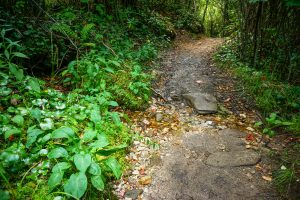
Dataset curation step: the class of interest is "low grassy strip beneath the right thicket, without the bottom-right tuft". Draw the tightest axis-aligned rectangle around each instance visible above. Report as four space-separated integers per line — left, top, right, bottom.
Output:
215 45 300 136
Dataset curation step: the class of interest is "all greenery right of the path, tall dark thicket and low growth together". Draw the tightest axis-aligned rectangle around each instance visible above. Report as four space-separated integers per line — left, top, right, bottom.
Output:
215 0 300 199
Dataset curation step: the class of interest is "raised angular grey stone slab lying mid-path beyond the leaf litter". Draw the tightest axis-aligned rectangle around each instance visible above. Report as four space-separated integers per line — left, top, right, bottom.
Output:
182 93 218 114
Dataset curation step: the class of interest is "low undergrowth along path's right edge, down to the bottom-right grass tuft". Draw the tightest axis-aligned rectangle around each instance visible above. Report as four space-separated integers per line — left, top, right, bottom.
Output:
214 44 300 198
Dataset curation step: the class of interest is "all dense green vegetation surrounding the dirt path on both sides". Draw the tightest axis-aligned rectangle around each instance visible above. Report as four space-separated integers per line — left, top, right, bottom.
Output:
0 0 300 199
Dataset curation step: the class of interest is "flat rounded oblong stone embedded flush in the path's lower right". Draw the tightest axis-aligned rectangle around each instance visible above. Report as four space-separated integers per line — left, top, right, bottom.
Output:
205 150 261 167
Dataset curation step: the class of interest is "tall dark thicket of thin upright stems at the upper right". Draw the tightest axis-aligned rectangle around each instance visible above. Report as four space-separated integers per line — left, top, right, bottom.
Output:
225 0 300 85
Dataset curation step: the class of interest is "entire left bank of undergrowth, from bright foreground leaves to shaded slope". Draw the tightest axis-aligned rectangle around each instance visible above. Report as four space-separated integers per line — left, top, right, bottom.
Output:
0 1 174 199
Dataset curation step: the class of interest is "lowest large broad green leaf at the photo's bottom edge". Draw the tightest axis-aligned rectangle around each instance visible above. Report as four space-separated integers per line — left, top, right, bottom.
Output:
64 172 87 199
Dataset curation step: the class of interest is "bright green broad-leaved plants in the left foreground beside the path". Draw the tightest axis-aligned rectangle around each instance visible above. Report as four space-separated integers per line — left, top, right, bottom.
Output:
0 31 130 198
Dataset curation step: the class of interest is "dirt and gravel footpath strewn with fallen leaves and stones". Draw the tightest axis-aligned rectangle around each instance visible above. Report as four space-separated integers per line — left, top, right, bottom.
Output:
115 35 278 200
